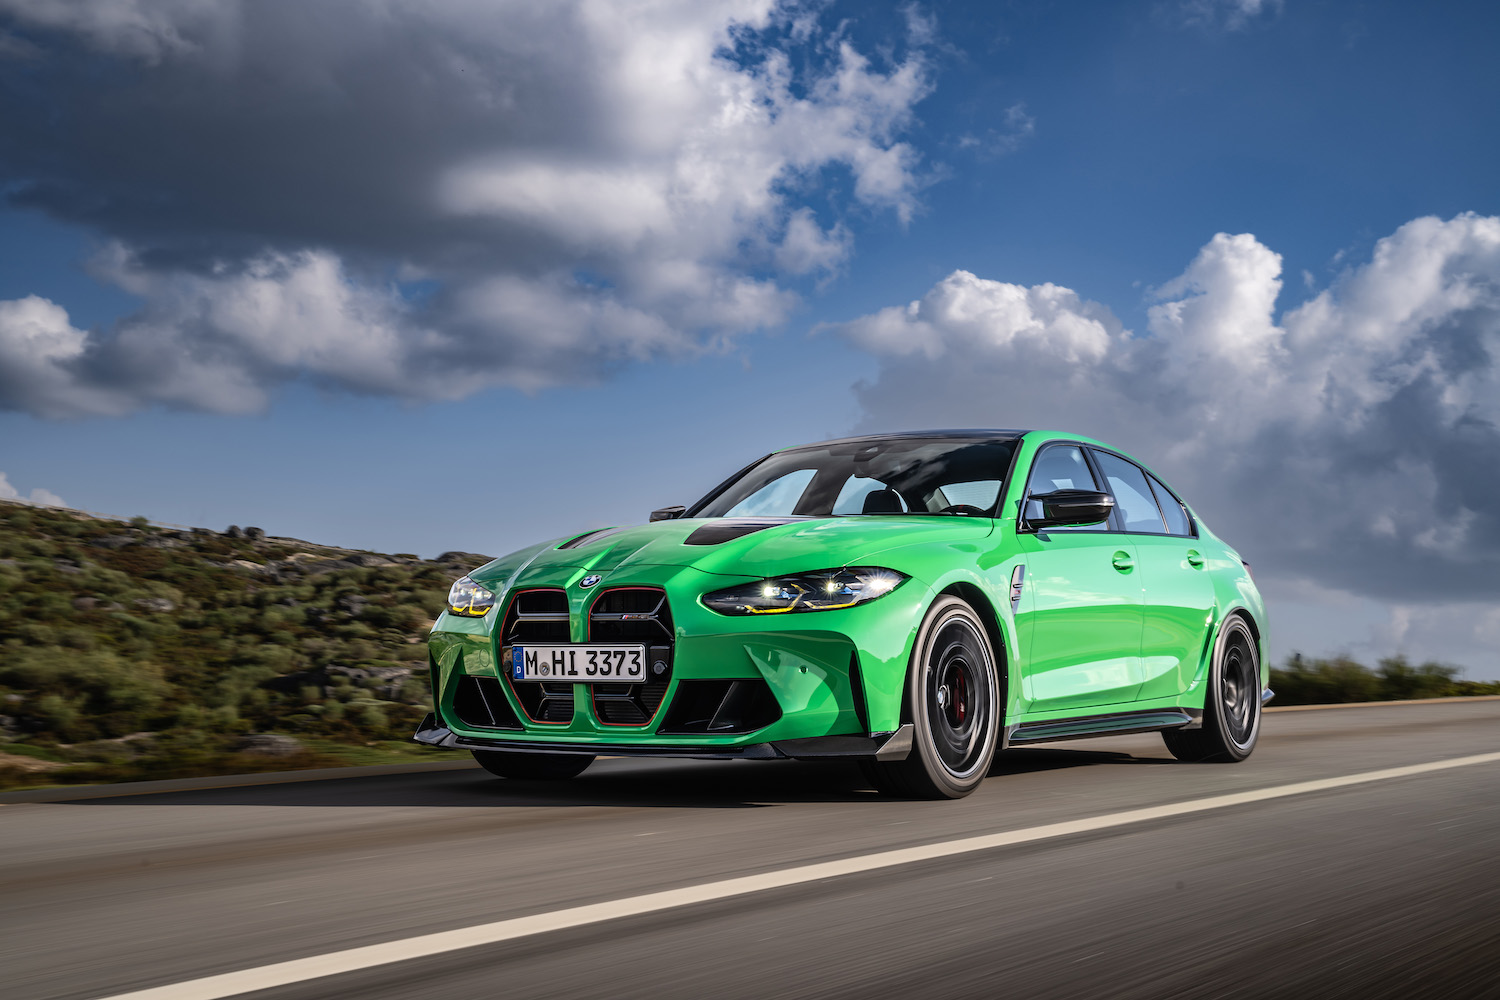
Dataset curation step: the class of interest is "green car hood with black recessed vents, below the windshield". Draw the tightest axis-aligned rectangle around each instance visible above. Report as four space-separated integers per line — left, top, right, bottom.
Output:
471 514 995 589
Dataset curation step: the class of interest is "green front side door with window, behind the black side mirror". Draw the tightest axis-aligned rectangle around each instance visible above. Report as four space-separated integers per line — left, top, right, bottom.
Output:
1016 444 1143 712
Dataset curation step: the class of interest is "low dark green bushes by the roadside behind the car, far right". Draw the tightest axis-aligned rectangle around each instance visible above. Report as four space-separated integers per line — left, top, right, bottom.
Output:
1271 654 1500 705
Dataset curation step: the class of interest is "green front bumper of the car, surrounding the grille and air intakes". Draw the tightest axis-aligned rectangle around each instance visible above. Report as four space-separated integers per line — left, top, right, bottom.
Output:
419 567 927 749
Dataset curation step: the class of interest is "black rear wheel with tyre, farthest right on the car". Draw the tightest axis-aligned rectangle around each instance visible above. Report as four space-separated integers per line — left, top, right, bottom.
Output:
1161 615 1260 763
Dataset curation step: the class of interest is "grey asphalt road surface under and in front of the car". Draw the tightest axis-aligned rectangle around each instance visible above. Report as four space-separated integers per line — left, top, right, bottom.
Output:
0 702 1500 1000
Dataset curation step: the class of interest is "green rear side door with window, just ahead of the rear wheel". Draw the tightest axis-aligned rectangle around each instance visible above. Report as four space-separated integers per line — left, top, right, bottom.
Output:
1094 448 1214 700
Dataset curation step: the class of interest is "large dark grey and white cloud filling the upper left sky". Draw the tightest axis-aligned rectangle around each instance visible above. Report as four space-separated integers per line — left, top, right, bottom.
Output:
0 0 932 417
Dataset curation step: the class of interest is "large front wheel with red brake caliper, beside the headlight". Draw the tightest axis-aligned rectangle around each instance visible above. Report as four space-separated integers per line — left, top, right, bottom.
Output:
863 597 1004 799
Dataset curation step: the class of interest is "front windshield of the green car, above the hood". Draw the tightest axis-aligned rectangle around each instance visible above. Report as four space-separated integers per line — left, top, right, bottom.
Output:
690 438 1016 517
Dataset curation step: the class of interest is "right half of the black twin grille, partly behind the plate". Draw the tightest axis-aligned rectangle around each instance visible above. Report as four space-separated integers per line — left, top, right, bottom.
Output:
588 586 677 727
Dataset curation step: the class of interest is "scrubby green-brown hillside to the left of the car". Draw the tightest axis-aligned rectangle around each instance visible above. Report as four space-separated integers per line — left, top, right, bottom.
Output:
0 504 488 786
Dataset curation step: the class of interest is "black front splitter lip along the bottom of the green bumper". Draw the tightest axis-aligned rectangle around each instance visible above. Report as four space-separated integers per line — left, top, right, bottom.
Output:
413 712 912 760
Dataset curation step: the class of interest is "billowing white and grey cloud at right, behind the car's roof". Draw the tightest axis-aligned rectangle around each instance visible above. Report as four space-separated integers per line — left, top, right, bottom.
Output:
839 214 1500 617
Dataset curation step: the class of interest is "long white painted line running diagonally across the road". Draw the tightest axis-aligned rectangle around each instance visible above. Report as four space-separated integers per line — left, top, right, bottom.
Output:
90 753 1500 1000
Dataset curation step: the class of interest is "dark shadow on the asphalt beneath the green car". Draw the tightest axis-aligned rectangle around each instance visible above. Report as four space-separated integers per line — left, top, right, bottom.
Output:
59 747 1166 810
